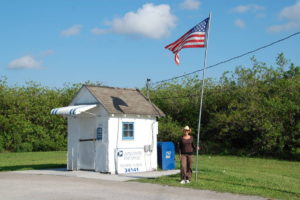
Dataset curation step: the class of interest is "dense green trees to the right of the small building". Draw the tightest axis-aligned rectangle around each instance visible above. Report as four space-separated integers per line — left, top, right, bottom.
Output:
150 53 300 157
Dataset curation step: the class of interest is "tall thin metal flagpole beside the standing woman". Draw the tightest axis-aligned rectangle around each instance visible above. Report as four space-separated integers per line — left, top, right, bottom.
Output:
195 12 211 182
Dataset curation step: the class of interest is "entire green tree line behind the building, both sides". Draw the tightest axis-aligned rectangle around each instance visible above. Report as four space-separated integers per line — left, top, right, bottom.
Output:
0 53 300 157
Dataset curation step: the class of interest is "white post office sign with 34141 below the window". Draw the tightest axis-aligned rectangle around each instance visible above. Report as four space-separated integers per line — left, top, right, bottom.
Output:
116 149 146 174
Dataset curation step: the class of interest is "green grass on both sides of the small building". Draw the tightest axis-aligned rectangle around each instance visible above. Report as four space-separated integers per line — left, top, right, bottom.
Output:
0 151 300 199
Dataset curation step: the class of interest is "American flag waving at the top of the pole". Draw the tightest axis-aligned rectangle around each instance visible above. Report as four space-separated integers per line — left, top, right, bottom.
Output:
165 18 209 65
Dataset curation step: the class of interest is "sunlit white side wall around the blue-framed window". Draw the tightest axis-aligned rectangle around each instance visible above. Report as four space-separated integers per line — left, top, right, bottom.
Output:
108 115 158 173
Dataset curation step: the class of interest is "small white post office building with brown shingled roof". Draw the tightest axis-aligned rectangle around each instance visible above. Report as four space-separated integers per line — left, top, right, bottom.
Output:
51 85 164 174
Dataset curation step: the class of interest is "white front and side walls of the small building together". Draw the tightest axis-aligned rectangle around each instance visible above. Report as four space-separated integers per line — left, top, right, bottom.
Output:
67 87 158 174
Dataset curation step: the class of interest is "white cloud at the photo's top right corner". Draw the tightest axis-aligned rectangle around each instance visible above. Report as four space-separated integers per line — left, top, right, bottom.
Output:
267 0 300 32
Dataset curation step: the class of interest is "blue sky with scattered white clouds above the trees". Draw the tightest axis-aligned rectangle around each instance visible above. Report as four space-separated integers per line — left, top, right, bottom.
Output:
0 0 300 88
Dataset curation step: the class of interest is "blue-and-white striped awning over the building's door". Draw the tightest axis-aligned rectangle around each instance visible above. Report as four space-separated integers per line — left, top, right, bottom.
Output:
50 104 97 115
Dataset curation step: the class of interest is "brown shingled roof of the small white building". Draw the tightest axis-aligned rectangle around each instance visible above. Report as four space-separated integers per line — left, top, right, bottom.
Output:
83 85 165 117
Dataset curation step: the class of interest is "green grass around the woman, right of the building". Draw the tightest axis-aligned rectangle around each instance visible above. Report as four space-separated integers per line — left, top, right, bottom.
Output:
139 155 300 199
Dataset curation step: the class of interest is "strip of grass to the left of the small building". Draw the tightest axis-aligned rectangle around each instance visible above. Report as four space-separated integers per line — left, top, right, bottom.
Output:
0 151 67 171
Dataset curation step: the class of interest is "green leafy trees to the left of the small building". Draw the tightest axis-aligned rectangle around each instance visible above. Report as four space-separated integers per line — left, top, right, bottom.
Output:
0 78 78 152
